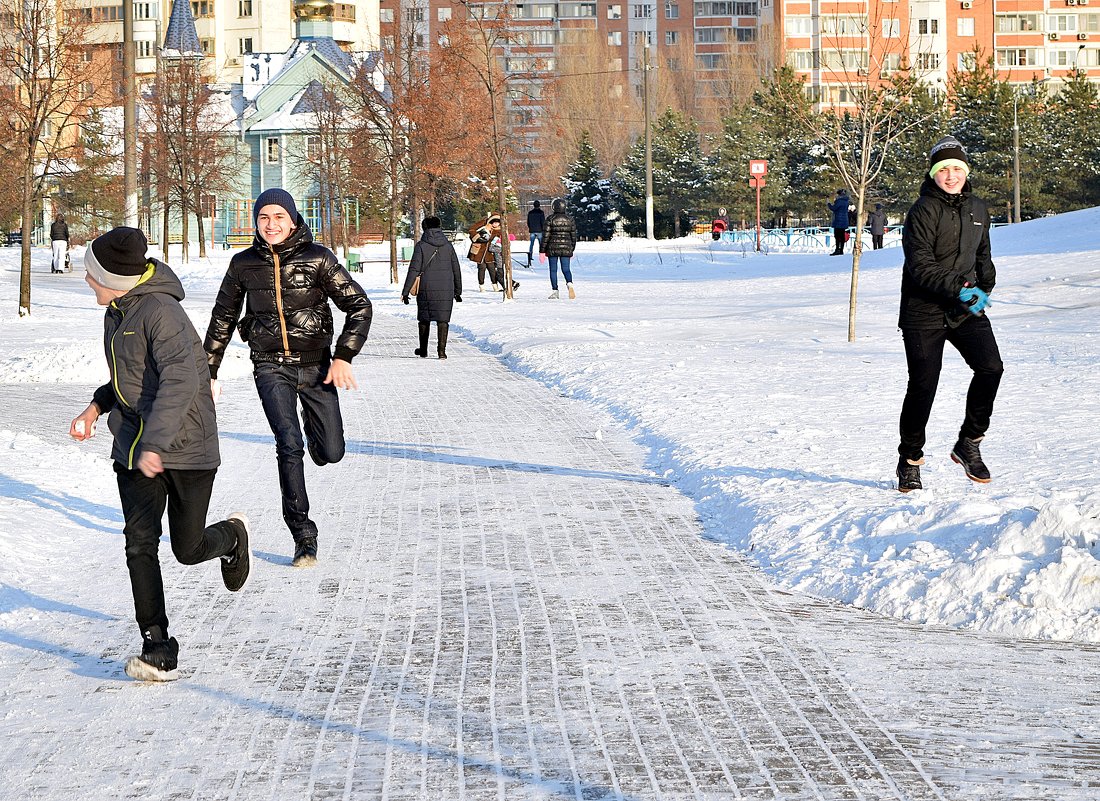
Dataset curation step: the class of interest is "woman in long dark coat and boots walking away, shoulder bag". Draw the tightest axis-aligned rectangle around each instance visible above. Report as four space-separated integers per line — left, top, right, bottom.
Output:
402 217 462 359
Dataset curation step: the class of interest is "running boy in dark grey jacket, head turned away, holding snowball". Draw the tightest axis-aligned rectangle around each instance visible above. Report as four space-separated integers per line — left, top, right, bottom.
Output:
69 228 251 681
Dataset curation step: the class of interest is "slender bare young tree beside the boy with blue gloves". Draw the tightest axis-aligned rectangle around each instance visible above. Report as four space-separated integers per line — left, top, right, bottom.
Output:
770 9 933 342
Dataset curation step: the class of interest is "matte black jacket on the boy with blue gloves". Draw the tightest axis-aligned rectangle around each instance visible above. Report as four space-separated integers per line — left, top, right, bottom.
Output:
898 178 997 329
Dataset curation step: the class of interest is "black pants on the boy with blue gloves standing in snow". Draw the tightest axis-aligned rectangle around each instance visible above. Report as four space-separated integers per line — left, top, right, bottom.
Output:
898 315 1004 461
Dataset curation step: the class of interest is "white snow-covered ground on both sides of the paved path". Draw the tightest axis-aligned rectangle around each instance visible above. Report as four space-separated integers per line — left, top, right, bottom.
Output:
0 209 1100 643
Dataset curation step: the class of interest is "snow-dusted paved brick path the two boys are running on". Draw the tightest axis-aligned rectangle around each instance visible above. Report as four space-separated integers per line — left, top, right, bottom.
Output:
0 317 1100 801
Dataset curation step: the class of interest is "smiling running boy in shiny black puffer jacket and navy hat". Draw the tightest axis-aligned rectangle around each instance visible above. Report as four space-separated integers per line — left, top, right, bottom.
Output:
205 189 371 568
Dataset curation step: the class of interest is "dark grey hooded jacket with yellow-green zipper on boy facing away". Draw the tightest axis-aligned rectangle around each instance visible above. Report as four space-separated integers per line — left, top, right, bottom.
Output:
92 260 221 470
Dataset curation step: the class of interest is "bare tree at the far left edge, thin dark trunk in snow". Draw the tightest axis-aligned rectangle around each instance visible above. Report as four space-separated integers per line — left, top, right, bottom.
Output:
0 0 90 317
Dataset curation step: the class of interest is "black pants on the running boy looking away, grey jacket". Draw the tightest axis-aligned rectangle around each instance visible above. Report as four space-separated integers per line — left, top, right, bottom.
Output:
114 462 237 634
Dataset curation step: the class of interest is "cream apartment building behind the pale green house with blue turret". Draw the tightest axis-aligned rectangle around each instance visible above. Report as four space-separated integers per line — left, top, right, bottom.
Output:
80 0 378 87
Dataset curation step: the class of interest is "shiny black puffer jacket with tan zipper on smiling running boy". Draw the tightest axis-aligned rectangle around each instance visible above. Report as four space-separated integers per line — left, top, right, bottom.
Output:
205 215 372 377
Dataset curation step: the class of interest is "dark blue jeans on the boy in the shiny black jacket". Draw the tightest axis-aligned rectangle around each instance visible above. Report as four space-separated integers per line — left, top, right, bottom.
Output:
253 359 344 541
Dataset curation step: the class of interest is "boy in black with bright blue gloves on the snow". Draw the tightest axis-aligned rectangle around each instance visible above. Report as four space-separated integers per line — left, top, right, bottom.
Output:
898 136 1004 492
